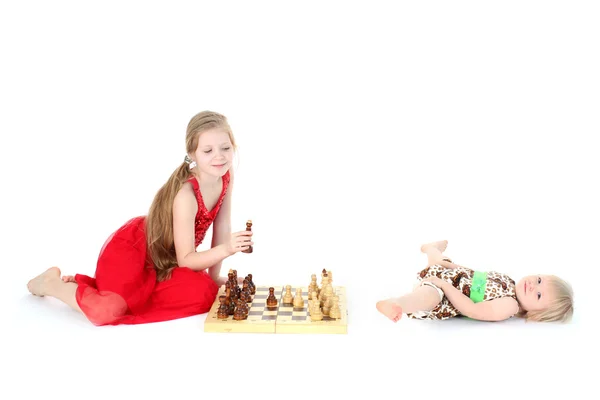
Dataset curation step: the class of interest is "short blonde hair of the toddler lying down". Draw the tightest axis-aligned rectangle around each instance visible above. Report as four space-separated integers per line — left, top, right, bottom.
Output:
519 275 573 322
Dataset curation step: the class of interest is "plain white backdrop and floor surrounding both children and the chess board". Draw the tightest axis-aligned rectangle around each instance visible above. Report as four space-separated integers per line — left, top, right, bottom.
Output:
0 1 600 399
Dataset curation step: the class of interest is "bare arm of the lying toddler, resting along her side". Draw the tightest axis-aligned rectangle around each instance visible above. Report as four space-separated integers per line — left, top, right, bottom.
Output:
433 279 519 321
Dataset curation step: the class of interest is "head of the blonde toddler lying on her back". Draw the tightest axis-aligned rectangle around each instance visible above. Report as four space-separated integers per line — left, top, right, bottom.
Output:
515 275 573 322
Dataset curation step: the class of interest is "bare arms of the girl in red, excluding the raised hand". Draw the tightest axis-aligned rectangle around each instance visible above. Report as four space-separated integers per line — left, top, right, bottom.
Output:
173 183 233 279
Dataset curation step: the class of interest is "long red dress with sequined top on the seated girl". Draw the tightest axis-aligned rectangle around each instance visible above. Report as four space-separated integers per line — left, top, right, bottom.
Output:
75 172 229 325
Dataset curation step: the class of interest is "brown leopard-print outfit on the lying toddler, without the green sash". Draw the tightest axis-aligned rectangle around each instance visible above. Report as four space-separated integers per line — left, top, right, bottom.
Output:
407 265 517 320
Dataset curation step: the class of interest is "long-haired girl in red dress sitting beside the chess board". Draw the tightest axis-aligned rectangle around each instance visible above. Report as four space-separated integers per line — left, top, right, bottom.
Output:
27 111 254 325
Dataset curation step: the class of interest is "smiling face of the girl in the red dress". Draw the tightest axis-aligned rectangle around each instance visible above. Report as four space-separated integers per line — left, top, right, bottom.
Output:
192 128 233 178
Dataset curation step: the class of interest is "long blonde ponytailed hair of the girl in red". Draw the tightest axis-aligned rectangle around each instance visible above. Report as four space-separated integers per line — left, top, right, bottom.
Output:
146 111 236 281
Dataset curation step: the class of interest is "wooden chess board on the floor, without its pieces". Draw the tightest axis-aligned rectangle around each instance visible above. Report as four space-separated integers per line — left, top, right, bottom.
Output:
204 286 348 334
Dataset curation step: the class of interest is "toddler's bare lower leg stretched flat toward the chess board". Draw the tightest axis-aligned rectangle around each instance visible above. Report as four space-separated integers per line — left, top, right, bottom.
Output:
377 285 440 322
